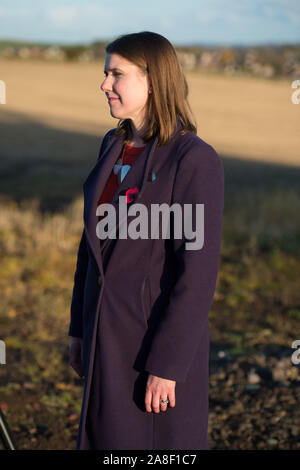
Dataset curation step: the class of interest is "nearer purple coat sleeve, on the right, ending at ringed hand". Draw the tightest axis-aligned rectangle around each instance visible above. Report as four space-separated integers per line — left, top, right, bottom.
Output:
145 143 224 382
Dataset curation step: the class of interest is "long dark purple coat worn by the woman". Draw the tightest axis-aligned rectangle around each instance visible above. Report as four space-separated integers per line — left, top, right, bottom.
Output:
68 115 224 450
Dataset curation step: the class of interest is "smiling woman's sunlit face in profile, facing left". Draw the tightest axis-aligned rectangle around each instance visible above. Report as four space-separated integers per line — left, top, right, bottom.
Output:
100 53 150 128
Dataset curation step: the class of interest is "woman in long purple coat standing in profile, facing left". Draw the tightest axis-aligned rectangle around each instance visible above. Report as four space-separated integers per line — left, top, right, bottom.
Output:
69 32 224 450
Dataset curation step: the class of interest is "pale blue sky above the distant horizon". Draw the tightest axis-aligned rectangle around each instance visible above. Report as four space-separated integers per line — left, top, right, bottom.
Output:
0 0 300 45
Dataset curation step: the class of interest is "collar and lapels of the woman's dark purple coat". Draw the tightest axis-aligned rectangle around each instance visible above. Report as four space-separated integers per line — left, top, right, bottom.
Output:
83 116 183 277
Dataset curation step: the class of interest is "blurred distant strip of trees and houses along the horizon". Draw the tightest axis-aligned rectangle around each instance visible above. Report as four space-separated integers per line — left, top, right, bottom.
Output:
0 41 300 79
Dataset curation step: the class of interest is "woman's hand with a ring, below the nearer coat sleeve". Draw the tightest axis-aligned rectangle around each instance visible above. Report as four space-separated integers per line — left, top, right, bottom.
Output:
145 374 176 413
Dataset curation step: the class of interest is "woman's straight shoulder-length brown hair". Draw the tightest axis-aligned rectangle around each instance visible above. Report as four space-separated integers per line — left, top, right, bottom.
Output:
105 31 197 146
